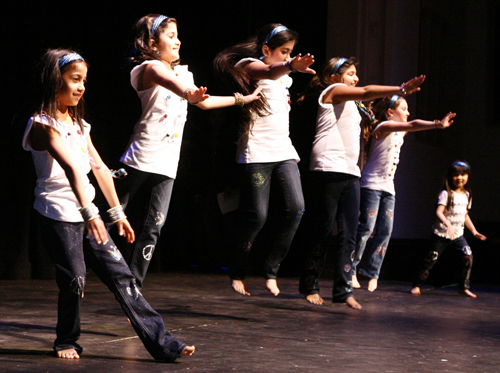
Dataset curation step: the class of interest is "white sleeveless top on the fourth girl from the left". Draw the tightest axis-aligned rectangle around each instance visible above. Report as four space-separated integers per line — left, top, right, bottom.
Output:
309 83 361 177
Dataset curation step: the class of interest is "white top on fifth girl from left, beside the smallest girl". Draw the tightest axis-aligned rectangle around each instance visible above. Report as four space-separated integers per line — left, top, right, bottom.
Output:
360 122 405 195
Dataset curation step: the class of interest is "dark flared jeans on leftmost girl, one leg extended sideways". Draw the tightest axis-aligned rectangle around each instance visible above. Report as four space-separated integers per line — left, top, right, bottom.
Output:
39 215 186 361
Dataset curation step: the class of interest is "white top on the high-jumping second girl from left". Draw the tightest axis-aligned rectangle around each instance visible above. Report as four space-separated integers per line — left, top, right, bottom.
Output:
120 60 194 178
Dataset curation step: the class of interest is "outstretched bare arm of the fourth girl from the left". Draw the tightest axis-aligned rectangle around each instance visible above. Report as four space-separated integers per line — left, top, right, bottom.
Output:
325 75 425 103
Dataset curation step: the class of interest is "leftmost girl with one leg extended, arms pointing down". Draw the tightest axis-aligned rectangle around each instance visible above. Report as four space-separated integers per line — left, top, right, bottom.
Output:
23 49 195 362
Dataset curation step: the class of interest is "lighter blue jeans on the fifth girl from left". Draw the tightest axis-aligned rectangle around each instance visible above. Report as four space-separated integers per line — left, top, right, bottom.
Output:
352 188 396 279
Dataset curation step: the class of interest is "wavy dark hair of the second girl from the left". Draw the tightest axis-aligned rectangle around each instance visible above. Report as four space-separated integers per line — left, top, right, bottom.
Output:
129 14 180 68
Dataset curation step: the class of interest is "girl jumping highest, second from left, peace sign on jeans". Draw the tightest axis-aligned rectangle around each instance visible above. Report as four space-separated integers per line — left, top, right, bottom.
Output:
117 14 260 288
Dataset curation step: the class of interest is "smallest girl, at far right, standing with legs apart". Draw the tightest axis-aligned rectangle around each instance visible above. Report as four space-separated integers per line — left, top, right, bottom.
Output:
411 161 486 298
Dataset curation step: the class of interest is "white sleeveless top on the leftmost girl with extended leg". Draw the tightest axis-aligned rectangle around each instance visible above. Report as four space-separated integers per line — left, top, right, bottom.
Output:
23 115 95 222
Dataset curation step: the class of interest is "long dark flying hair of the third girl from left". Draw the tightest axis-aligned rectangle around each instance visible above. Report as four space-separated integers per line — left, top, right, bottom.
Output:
214 23 299 142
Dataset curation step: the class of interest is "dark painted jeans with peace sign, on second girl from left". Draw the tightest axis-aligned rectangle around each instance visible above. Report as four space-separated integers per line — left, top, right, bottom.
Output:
116 166 175 289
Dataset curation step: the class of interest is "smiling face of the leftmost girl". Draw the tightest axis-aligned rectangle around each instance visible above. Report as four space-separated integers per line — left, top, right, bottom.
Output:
57 62 88 112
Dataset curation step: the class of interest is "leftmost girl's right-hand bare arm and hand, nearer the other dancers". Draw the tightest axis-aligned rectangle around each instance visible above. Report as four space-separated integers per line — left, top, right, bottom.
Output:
87 136 135 243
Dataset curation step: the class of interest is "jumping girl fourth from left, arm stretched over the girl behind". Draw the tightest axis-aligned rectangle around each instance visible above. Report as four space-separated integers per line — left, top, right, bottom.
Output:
299 57 425 309
